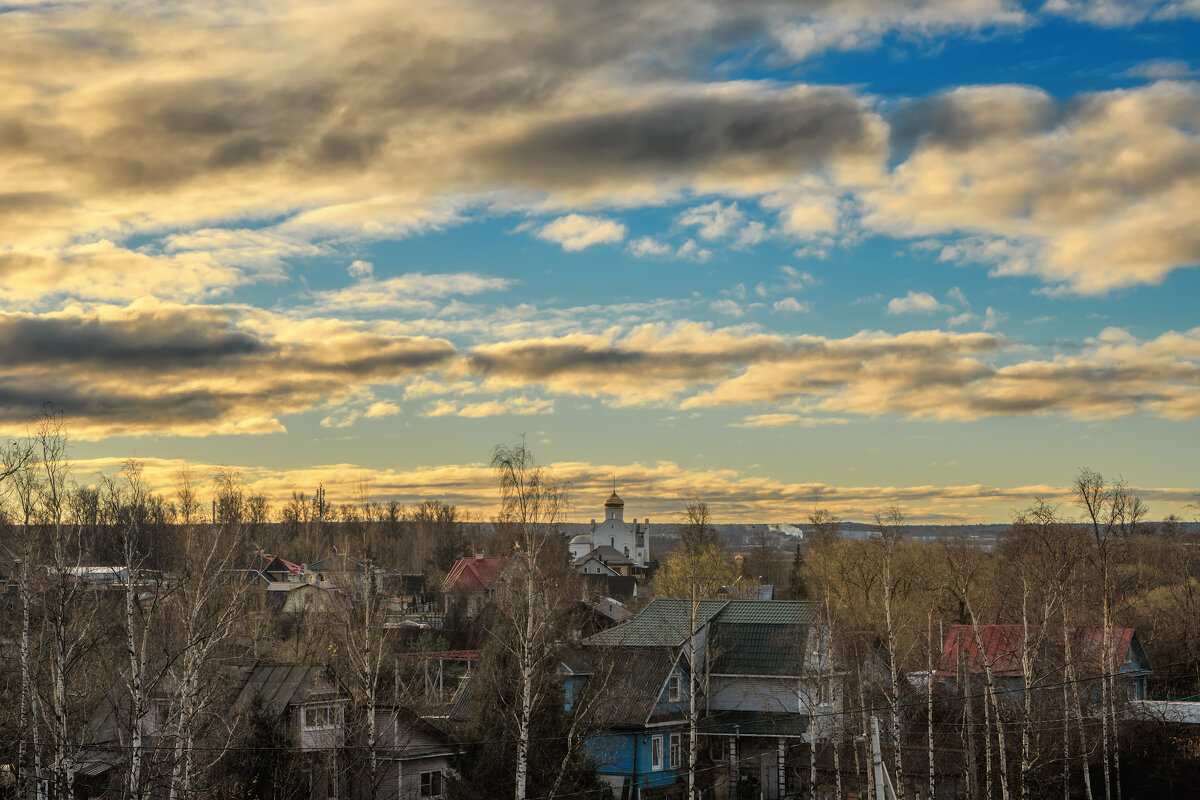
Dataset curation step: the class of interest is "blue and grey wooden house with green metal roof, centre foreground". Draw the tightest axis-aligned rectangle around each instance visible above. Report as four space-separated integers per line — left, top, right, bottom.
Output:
560 600 829 799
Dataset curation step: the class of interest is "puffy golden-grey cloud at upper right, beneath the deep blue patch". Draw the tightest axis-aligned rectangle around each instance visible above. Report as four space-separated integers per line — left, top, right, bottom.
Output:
863 82 1200 294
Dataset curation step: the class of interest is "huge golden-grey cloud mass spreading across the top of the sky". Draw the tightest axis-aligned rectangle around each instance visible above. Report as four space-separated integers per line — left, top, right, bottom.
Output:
0 0 1200 301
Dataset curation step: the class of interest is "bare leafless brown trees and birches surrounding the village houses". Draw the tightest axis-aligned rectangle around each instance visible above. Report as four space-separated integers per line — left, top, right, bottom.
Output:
0 411 1200 800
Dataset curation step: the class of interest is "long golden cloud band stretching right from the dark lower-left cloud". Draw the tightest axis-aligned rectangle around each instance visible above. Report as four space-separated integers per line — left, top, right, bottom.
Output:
468 324 1200 427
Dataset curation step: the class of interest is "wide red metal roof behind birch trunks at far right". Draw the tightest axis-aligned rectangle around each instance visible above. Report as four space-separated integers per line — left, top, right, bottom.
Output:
937 625 1140 675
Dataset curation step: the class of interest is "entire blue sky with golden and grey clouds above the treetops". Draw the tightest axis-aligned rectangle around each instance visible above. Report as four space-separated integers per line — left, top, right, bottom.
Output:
0 0 1200 523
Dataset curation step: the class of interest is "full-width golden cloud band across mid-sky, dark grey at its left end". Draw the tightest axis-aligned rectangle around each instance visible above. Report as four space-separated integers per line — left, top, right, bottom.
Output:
0 298 1200 439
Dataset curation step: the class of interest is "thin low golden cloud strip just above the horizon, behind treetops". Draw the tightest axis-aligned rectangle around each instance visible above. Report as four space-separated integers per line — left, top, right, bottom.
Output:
65 458 1193 524
